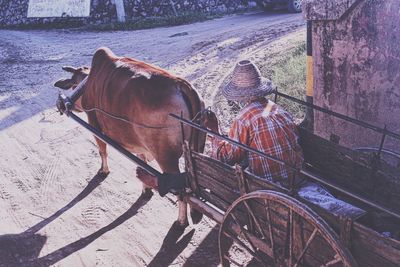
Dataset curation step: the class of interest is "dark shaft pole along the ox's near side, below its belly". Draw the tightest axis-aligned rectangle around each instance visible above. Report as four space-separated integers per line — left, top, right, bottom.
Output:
67 111 161 177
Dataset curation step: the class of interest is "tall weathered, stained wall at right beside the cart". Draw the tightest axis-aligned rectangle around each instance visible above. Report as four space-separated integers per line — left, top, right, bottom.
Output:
303 0 400 152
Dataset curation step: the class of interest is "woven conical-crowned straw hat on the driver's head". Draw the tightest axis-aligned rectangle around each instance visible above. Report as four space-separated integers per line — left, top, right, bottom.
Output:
222 60 274 101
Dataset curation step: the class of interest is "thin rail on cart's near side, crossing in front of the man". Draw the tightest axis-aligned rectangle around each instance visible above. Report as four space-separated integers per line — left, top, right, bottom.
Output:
169 113 300 174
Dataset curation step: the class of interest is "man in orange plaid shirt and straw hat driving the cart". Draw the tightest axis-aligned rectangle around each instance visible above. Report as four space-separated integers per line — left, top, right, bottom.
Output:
205 60 303 181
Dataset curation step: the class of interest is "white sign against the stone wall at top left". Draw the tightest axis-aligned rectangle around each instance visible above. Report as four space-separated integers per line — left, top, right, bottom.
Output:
28 0 90 18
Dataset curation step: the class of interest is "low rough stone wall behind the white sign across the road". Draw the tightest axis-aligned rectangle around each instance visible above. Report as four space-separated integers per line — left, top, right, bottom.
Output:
0 0 246 26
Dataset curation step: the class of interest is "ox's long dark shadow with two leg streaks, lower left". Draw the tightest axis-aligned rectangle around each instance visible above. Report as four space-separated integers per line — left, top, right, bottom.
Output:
0 174 149 267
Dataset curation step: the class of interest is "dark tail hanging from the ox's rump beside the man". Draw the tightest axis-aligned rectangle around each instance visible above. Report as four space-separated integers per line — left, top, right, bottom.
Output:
178 78 207 153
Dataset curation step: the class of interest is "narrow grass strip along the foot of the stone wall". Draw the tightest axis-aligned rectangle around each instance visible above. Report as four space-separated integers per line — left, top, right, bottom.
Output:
84 12 224 31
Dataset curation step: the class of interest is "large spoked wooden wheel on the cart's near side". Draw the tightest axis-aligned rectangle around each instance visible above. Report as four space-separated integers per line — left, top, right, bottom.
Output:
218 190 357 267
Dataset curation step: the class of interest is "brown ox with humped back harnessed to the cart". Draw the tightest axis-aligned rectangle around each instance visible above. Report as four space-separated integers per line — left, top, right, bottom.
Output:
54 48 205 226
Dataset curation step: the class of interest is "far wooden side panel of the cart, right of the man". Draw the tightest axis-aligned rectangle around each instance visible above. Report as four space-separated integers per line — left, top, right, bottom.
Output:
300 129 400 215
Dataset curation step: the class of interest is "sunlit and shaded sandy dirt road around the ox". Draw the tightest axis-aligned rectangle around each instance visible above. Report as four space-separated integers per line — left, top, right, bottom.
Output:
0 13 304 266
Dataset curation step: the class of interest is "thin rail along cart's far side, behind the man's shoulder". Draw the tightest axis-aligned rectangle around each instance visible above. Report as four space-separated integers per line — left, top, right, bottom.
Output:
275 92 400 140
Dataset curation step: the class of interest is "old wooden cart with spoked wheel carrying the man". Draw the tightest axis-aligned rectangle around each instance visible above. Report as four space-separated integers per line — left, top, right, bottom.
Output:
171 92 400 267
